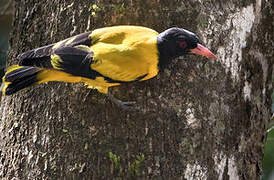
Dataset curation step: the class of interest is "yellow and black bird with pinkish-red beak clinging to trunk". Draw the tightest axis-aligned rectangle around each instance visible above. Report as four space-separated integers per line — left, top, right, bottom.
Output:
1 25 217 107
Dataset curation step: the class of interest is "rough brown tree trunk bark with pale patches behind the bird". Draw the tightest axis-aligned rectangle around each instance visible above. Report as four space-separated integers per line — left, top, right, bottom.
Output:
0 0 274 180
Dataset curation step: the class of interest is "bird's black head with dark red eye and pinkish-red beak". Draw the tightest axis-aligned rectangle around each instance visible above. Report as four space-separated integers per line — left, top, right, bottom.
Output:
157 27 216 67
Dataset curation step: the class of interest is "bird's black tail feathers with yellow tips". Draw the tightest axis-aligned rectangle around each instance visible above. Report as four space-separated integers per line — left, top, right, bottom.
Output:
2 65 42 95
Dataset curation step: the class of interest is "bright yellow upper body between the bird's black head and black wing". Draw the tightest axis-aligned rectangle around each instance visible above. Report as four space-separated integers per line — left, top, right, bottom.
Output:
90 26 158 81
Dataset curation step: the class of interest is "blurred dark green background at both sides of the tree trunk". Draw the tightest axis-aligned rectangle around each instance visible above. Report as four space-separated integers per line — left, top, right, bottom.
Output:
0 0 274 180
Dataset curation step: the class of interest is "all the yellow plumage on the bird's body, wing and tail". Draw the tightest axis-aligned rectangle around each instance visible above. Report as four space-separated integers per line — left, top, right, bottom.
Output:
3 26 158 93
